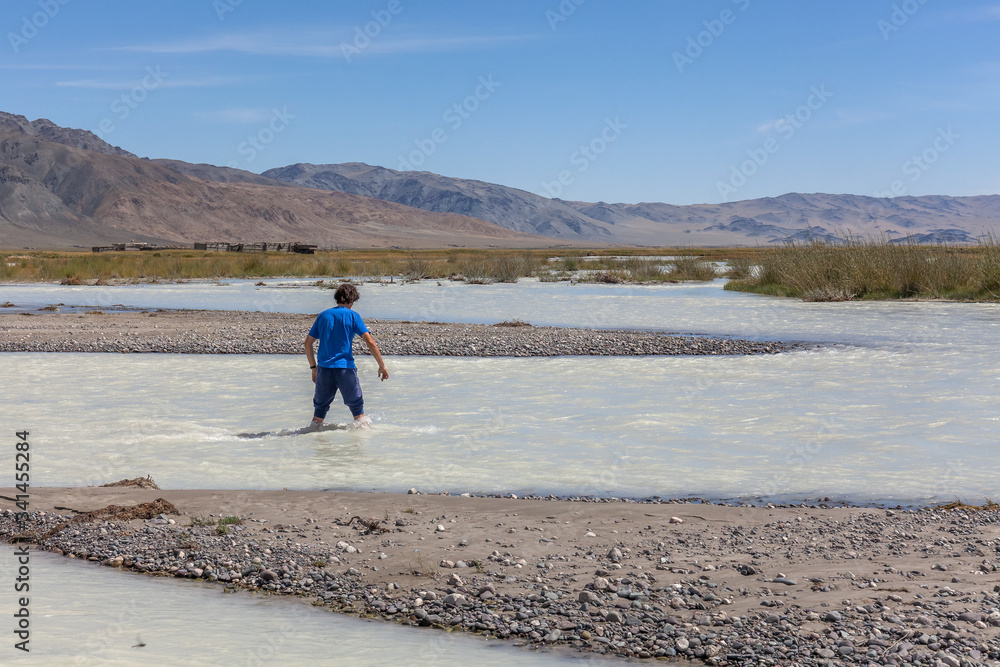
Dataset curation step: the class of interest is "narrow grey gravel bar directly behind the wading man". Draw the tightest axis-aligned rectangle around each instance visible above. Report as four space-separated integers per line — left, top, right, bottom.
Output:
0 307 804 357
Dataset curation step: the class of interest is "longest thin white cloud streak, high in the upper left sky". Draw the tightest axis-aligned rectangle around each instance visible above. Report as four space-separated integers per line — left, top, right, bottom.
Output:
108 30 531 58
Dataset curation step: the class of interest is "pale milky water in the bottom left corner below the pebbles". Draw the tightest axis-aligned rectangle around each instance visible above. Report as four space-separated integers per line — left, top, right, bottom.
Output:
0 545 620 667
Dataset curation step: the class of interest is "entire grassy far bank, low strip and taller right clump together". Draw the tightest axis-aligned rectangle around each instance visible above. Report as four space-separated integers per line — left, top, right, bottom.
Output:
11 243 1000 301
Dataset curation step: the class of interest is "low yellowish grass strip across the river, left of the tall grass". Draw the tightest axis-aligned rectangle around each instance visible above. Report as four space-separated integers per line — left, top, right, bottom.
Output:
0 249 728 283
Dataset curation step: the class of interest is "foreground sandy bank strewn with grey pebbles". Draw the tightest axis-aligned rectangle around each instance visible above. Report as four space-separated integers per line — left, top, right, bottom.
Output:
0 487 1000 667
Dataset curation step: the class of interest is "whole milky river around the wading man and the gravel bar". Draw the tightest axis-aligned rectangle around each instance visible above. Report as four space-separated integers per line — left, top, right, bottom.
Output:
0 280 1000 503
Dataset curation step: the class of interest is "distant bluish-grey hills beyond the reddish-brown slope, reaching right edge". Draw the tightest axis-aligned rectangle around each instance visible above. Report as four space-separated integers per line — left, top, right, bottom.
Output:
262 162 1000 246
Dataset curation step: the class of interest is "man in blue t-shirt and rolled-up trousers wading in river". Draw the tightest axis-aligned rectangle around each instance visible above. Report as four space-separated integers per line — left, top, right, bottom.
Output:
306 284 389 428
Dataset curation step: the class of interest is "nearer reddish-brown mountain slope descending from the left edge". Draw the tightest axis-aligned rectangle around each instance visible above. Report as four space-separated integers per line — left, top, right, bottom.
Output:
0 126 551 248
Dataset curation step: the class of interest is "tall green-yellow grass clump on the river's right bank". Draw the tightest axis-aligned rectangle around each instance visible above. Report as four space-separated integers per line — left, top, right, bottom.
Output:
726 237 1000 301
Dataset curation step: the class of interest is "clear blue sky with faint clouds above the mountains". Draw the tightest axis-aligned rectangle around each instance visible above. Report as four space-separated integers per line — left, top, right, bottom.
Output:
0 0 1000 204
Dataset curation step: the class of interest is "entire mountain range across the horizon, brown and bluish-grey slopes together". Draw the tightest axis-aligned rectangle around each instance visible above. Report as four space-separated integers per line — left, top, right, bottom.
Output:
0 112 1000 247
